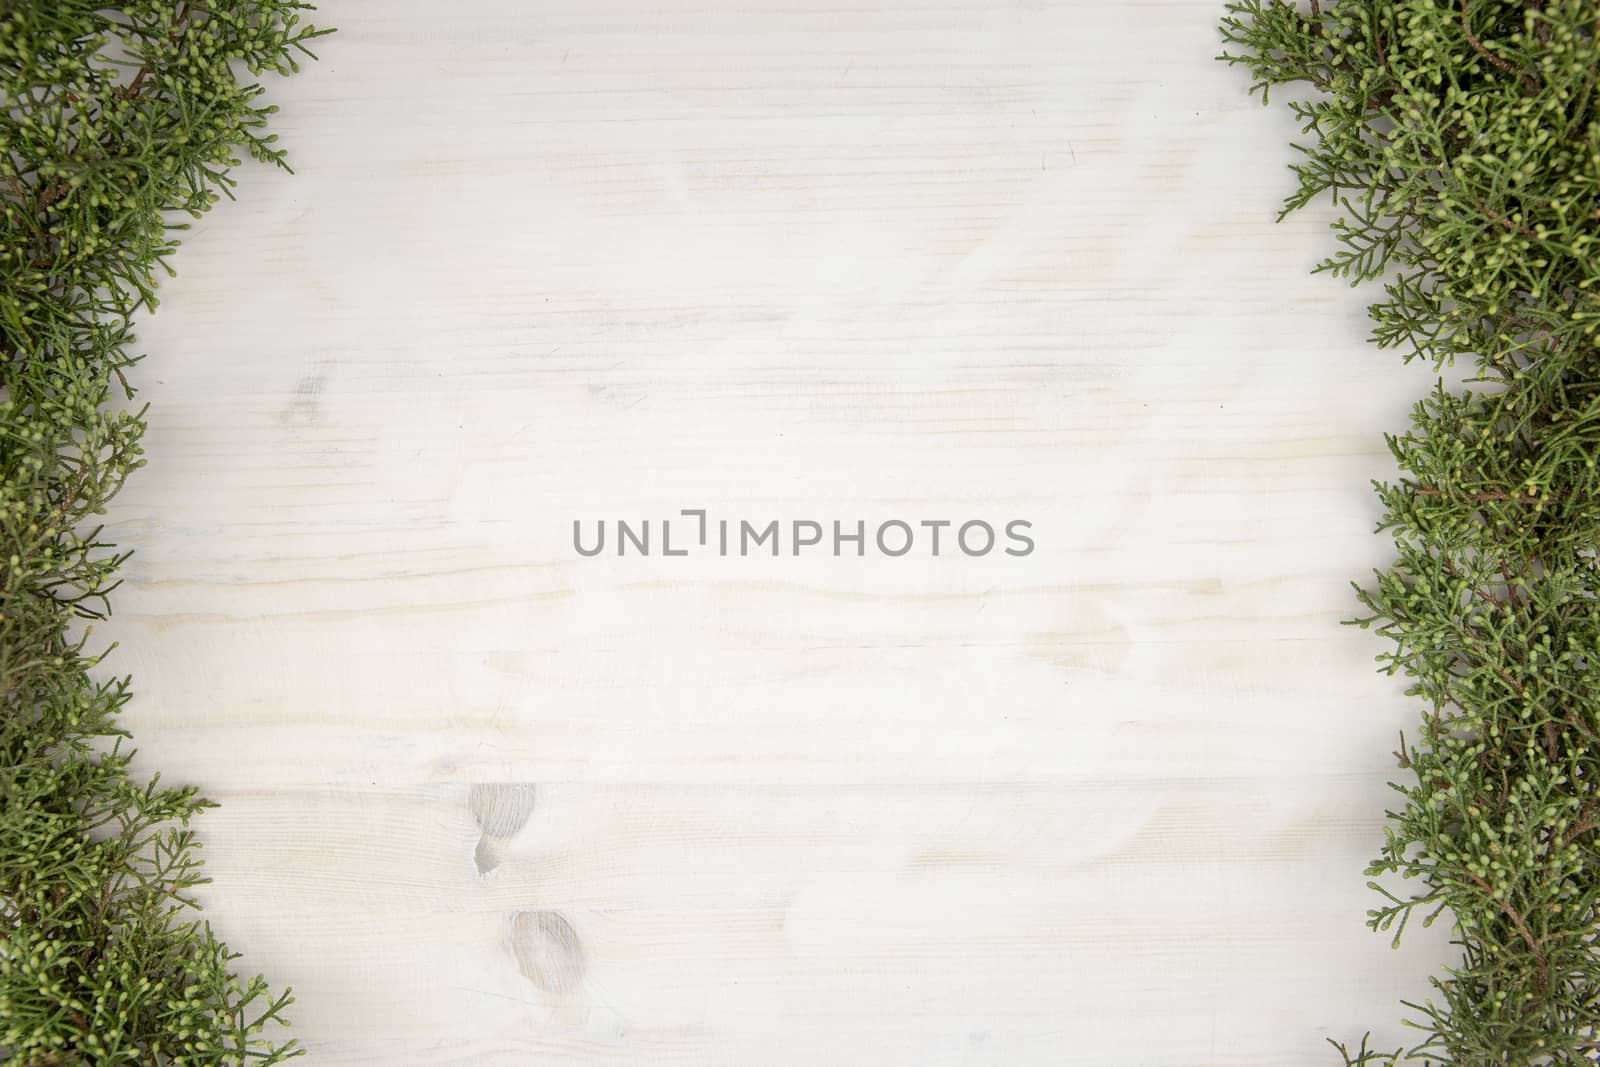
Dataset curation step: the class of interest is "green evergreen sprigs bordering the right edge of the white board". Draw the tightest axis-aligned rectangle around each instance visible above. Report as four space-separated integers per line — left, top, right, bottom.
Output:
1221 0 1600 1065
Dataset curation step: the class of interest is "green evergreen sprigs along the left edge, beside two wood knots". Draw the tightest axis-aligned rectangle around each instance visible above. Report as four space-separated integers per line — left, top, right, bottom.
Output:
0 0 323 1067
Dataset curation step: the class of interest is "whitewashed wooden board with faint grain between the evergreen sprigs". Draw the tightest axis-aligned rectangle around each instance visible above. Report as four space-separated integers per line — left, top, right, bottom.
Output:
99 0 1465 1067
